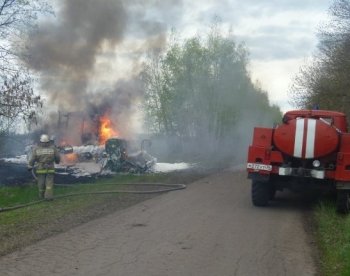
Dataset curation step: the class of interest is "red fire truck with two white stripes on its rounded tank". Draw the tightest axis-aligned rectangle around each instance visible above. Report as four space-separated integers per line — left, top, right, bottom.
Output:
247 110 350 213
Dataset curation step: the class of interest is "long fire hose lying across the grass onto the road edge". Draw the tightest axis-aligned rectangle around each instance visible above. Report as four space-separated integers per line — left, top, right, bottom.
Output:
0 170 186 213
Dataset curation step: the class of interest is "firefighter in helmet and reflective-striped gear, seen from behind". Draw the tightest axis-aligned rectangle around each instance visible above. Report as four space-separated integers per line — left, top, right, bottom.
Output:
28 134 60 200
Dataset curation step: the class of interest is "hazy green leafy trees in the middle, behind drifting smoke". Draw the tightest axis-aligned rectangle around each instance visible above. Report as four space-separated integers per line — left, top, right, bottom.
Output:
143 25 281 163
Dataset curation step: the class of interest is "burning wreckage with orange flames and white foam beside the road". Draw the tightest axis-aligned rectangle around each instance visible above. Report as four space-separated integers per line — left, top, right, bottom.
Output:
52 113 156 173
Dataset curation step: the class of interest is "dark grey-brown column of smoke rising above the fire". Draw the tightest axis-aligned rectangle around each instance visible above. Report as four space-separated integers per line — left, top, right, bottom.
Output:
29 0 128 108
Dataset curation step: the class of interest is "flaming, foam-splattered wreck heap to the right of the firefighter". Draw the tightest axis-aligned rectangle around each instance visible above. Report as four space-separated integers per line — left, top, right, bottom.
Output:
46 110 156 173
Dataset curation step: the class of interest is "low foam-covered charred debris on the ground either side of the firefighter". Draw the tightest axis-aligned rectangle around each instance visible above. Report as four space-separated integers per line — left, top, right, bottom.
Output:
0 135 157 185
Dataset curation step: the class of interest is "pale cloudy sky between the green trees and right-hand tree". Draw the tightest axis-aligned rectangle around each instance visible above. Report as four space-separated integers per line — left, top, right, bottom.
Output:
170 0 332 111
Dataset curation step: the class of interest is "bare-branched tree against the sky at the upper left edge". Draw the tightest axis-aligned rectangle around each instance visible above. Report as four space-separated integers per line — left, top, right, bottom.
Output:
0 0 51 130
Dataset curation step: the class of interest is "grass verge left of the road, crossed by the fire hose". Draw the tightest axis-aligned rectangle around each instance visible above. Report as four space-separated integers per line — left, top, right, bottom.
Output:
0 174 171 256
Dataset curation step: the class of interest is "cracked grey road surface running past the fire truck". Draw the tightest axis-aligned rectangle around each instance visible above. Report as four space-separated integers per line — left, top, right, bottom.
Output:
0 171 317 276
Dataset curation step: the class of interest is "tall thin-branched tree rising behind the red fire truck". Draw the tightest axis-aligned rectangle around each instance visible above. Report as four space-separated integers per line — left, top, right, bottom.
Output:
290 0 350 116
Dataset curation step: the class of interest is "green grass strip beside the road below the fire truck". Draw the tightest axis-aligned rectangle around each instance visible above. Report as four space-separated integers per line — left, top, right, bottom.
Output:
314 200 350 276
